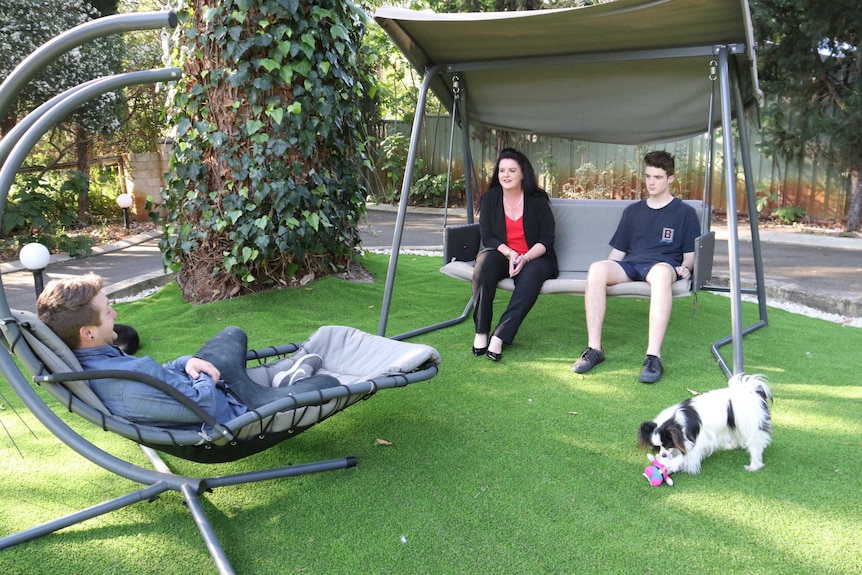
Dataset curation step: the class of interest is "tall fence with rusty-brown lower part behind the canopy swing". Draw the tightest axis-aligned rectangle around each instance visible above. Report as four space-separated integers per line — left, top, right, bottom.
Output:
373 115 850 221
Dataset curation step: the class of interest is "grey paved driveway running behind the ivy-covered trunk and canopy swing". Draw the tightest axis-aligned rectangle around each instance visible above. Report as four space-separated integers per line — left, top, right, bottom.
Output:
0 206 862 318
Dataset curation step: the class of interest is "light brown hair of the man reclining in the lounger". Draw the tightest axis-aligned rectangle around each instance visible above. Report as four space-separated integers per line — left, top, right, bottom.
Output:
36 274 103 349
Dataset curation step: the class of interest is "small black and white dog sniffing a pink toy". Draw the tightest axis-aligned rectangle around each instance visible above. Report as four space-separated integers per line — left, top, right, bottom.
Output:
638 374 772 473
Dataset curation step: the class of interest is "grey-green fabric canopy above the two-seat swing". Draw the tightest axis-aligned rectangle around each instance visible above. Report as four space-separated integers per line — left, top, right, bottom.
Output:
374 0 759 144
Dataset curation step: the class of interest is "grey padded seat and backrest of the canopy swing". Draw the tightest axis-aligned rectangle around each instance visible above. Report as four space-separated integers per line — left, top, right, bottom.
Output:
440 198 714 298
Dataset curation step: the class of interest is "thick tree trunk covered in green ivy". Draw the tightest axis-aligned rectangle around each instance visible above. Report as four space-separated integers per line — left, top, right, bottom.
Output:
161 0 370 303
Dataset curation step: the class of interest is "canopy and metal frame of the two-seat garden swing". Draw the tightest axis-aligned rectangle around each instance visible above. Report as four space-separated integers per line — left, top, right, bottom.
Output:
374 0 767 377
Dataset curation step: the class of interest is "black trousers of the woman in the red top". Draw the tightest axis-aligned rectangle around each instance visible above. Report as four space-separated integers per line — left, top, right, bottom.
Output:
473 249 553 345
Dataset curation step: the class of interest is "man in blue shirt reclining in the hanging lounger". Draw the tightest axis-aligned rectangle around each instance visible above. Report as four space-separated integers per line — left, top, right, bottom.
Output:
36 274 339 428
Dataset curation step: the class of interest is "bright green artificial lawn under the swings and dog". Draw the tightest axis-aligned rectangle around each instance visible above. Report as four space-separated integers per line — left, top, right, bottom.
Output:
0 255 862 575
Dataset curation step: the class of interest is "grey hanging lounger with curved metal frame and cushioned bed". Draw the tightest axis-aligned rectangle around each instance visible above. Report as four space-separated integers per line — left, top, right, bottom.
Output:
0 12 440 575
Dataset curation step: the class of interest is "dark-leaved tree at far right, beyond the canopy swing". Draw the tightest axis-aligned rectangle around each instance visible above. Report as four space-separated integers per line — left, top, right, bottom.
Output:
751 0 862 231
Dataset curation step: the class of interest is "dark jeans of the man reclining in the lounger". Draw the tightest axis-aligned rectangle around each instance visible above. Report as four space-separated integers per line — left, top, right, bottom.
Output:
195 326 340 409
